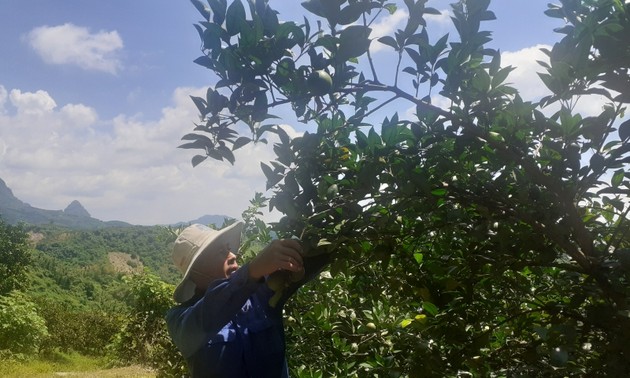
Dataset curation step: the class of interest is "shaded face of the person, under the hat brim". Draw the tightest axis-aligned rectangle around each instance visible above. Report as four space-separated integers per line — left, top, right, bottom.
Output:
190 249 238 290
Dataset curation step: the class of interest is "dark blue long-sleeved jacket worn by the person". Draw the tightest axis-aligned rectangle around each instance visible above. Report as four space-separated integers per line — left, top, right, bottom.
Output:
166 256 328 378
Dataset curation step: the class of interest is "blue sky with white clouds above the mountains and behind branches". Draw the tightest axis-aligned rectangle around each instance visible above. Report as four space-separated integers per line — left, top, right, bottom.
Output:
0 0 572 224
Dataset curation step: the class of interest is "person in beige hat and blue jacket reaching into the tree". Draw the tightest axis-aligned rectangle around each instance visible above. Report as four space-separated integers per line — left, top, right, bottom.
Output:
166 222 327 378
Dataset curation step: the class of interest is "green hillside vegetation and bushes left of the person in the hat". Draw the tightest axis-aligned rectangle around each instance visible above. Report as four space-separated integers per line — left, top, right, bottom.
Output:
0 222 179 376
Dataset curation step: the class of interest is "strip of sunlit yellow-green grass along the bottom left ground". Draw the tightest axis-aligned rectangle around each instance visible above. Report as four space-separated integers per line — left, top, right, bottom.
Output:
0 352 155 378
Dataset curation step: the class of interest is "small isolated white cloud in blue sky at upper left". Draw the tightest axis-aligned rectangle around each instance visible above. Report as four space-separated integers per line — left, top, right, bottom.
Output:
27 23 123 74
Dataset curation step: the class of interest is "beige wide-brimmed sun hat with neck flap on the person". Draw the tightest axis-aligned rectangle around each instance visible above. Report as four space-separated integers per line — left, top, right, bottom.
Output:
173 222 243 303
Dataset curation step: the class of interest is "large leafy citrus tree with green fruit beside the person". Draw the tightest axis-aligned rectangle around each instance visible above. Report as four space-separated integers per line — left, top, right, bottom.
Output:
181 0 630 377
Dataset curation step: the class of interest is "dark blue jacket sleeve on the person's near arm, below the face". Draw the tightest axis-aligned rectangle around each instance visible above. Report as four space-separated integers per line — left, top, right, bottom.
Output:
166 265 261 358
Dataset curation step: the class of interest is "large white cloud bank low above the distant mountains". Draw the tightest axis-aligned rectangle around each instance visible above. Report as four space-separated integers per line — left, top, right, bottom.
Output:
0 88 282 224
